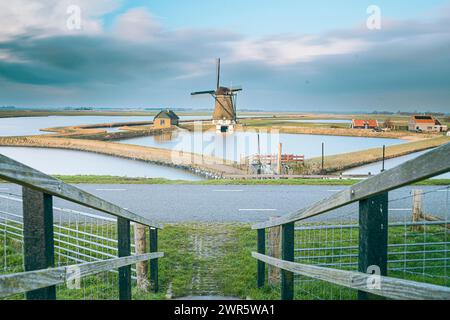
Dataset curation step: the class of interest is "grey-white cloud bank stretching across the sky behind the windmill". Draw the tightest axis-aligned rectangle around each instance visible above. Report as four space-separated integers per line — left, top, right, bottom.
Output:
0 0 450 110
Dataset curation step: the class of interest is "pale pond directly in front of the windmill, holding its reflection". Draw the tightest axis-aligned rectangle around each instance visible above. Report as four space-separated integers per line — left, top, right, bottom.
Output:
119 131 404 161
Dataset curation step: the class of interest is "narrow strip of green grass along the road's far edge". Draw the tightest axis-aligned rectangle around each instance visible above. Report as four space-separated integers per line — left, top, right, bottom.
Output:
44 175 450 186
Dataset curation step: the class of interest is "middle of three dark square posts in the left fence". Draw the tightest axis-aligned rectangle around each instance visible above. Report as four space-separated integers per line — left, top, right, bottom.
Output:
117 217 131 300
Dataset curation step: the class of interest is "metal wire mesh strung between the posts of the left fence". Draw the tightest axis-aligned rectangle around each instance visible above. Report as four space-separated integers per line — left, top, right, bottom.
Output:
0 192 144 300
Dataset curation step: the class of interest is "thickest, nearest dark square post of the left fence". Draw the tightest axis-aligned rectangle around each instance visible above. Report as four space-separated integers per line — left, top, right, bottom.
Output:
22 187 56 300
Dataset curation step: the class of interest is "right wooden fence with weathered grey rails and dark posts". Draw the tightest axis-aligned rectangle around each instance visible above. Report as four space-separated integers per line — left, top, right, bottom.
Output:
252 143 450 300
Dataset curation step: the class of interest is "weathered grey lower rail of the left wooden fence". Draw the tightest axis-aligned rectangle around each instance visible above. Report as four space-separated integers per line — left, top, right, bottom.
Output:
0 252 164 298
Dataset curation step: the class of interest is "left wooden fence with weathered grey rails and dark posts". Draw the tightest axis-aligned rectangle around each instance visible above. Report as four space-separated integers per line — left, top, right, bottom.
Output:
0 155 164 300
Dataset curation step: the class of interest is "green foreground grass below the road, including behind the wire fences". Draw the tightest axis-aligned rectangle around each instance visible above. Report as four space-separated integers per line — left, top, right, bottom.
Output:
0 224 450 300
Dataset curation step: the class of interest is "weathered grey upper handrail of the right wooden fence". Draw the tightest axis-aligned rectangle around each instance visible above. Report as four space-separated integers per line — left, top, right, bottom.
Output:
252 143 450 229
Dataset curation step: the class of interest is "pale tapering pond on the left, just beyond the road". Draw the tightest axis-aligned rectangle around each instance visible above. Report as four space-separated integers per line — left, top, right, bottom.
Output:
0 147 201 181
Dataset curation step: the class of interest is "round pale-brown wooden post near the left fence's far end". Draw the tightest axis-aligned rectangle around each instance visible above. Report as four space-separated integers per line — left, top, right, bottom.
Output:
134 223 150 292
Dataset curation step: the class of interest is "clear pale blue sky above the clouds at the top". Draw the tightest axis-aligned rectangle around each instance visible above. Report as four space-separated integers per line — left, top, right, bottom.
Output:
105 0 448 35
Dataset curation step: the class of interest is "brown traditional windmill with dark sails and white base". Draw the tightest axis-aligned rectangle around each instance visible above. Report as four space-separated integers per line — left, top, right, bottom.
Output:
191 59 242 132
